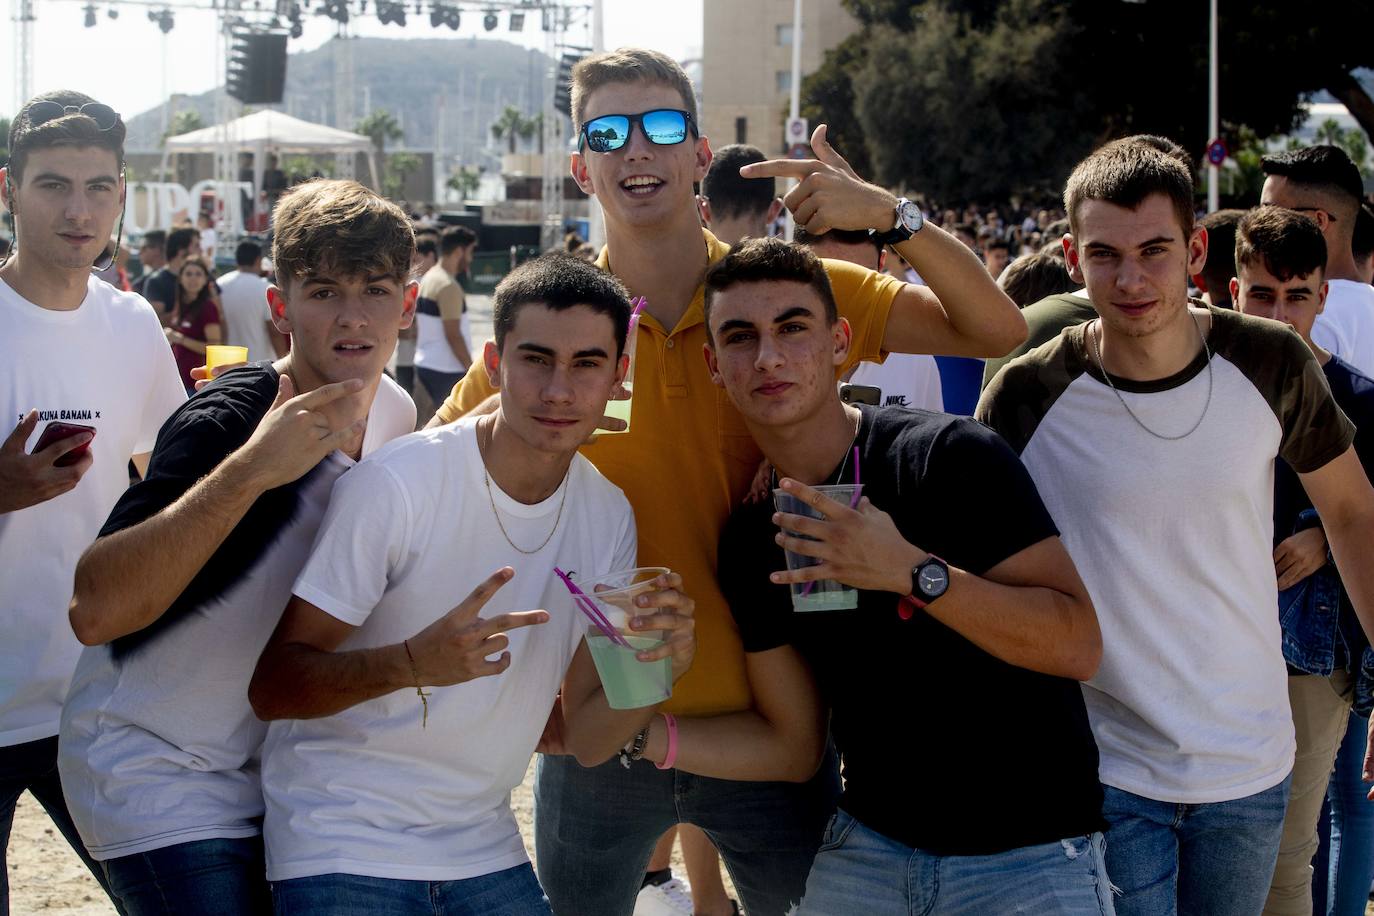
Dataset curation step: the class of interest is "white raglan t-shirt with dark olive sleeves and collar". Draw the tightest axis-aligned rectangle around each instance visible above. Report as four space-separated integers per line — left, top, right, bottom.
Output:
978 309 1353 805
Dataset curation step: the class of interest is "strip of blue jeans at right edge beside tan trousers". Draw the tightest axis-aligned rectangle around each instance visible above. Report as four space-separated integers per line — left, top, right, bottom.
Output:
1316 713 1374 916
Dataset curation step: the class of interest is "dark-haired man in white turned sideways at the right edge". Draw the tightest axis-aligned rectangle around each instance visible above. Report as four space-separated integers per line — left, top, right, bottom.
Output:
1260 146 1374 376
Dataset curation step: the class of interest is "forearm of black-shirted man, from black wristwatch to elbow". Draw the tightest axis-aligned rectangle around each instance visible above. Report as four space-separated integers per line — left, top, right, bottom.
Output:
925 566 1102 681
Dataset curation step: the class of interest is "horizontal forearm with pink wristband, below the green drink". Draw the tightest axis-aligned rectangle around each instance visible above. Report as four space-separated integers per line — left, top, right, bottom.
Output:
644 710 826 783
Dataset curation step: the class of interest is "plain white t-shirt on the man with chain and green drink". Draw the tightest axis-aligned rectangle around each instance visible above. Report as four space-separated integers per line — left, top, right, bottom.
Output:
262 417 636 880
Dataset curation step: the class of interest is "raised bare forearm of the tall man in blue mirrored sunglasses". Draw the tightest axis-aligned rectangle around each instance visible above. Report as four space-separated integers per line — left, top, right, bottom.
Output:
893 224 1026 357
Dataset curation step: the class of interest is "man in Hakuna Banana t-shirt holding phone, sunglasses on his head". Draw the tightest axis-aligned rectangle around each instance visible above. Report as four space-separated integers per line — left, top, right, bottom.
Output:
0 91 185 912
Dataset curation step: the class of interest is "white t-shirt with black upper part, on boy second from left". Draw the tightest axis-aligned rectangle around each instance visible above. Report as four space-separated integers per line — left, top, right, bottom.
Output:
58 367 415 861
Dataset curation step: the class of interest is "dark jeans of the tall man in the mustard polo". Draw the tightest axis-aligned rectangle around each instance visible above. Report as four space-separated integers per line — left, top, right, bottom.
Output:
534 753 840 916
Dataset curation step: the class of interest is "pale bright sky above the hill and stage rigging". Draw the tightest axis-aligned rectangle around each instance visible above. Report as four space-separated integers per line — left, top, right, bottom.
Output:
0 0 702 117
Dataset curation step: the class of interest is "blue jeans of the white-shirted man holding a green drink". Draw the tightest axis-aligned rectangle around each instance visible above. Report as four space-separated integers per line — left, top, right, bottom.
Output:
272 862 552 916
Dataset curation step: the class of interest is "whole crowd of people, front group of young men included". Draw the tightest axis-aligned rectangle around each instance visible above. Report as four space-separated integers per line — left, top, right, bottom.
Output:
0 41 1374 916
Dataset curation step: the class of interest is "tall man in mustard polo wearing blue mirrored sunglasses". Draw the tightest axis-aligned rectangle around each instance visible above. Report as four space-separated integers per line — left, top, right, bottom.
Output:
437 48 1025 916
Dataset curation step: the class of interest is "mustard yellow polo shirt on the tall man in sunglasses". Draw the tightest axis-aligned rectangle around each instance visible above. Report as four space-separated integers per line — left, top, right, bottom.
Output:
438 229 901 715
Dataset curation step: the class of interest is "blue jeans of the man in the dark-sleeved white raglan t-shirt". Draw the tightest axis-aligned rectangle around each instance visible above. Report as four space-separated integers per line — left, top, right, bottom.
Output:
1102 775 1292 916
